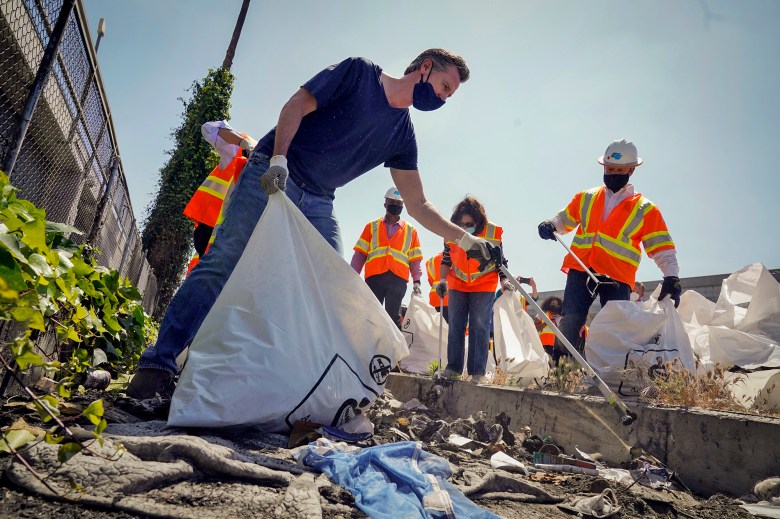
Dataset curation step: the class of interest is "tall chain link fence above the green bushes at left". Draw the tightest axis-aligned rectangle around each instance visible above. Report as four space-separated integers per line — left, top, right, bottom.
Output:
0 0 157 313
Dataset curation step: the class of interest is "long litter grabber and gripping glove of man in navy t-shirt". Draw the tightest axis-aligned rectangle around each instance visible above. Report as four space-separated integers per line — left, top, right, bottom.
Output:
467 244 637 426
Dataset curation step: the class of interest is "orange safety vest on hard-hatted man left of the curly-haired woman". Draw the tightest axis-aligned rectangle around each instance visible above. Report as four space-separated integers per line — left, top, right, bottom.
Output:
354 217 422 280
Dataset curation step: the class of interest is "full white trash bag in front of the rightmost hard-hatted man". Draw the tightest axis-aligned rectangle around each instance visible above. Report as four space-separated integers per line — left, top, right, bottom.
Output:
585 298 696 396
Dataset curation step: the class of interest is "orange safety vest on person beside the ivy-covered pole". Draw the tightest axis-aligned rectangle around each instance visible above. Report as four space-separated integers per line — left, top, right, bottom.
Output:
184 149 247 227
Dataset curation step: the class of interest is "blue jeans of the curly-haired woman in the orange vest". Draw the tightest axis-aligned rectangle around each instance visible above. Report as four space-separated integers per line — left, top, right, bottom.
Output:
447 290 495 376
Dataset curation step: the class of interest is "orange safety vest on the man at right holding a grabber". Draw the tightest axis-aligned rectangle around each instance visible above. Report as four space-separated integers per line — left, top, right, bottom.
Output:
558 186 674 287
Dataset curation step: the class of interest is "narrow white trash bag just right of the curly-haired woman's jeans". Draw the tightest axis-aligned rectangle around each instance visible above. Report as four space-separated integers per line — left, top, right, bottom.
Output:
493 292 549 386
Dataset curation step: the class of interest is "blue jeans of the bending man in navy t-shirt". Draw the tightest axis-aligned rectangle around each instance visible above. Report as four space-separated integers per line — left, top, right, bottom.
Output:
138 153 341 374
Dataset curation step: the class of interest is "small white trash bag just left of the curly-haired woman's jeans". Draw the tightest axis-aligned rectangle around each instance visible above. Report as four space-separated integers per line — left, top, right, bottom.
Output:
399 294 449 374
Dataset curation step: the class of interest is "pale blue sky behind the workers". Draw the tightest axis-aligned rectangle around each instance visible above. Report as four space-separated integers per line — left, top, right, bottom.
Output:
84 0 780 290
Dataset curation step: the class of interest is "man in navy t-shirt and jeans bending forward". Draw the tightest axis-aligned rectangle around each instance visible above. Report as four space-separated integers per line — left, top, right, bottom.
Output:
127 49 488 398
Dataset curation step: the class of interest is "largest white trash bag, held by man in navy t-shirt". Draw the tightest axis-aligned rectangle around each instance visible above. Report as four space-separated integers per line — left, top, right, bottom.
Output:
168 193 408 432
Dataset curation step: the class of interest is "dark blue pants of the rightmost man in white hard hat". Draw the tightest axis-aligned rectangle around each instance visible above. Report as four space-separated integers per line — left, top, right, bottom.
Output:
556 269 631 363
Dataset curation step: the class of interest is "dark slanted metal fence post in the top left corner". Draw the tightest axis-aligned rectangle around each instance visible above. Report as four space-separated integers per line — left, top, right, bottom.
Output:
3 0 76 178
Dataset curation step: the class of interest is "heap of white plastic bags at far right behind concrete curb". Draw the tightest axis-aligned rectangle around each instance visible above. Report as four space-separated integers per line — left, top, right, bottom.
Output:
585 263 780 410
